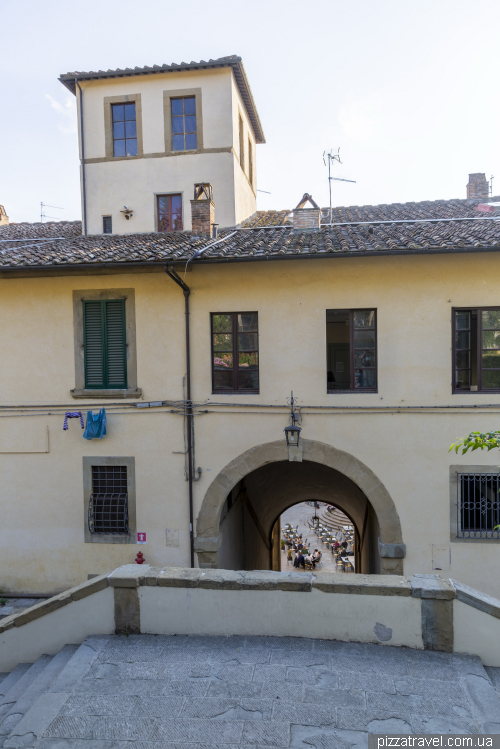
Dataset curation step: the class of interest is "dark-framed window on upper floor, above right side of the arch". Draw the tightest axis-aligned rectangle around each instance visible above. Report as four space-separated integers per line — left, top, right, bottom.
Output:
326 309 377 393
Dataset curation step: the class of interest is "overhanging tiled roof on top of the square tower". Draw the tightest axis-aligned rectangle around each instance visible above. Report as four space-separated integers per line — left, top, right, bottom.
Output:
59 55 266 143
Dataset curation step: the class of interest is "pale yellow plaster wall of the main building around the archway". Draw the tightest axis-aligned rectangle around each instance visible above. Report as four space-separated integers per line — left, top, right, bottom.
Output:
0 253 500 597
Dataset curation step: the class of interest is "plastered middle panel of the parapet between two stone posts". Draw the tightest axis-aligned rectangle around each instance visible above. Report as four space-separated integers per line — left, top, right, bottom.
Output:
139 587 423 648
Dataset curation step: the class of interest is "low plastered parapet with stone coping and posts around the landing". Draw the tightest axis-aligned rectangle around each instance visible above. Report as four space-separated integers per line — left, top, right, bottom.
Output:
0 564 500 671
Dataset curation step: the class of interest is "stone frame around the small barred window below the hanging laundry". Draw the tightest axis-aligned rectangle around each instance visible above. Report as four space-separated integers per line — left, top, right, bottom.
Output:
82 455 137 544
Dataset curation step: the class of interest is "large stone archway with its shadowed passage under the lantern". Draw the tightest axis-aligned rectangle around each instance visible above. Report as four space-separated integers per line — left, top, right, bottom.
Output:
195 440 404 574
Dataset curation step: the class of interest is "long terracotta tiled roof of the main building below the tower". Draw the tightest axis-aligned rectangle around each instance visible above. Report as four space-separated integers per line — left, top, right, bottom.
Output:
0 200 500 270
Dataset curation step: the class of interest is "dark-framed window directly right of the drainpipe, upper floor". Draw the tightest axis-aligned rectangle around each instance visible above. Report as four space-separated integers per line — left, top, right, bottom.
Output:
212 312 259 393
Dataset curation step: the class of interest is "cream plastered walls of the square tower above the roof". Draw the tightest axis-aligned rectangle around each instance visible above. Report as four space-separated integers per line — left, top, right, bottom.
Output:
76 68 256 234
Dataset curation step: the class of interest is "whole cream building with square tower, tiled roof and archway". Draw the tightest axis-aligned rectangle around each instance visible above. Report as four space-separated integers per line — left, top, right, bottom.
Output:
0 57 500 595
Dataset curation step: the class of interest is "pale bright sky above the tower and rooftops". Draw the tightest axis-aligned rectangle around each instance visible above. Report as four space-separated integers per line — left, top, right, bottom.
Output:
0 0 500 222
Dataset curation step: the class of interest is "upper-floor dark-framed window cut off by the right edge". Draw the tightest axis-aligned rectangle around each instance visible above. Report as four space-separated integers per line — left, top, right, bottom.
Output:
453 307 500 393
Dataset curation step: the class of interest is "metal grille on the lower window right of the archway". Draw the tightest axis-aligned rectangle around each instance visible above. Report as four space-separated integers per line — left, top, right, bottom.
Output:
457 473 500 538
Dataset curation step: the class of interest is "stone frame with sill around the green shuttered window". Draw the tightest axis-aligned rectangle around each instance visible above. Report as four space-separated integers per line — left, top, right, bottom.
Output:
70 289 142 399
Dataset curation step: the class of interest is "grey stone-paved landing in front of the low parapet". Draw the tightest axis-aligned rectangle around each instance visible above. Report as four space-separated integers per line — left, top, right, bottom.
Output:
15 635 500 749
